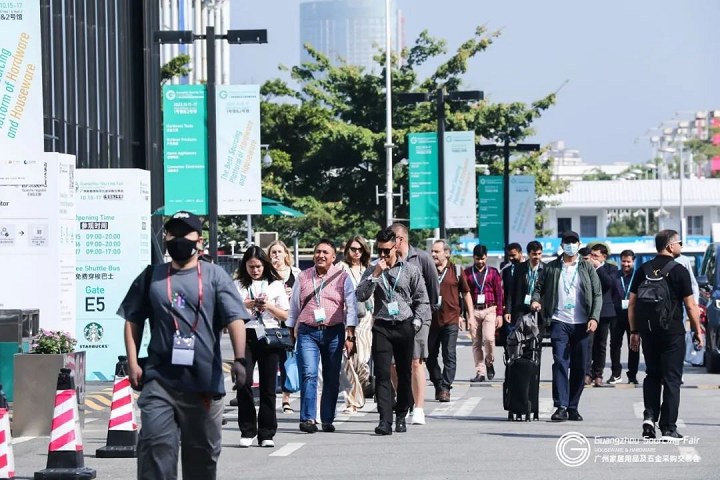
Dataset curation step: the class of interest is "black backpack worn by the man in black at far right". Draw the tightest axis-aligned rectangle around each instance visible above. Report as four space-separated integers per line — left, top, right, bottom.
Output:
635 260 678 330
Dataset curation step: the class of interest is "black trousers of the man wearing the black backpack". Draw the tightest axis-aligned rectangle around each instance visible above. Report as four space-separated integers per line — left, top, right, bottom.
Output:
640 331 685 431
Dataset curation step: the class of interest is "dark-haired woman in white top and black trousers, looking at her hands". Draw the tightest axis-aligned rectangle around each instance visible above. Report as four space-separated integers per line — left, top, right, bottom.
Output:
235 245 290 447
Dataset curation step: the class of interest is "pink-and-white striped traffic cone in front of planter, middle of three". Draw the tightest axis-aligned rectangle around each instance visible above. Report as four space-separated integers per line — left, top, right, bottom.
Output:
35 368 96 480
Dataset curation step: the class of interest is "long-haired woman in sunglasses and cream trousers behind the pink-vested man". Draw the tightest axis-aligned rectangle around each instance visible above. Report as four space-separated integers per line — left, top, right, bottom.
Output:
340 235 373 413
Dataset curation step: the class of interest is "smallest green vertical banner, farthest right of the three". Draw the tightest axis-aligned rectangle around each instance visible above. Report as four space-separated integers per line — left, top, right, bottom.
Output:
478 175 505 250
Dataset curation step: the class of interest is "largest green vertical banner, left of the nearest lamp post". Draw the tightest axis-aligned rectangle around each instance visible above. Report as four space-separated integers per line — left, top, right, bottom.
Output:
163 85 208 215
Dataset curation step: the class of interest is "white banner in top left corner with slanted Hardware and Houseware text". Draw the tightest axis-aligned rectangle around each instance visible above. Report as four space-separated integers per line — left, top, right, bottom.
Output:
0 0 45 185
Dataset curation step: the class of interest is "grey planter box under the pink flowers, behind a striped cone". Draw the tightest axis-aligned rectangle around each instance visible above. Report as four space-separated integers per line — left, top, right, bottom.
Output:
12 352 85 437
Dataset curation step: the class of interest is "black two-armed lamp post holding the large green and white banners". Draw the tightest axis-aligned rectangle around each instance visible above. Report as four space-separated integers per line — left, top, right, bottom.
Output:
153 26 267 262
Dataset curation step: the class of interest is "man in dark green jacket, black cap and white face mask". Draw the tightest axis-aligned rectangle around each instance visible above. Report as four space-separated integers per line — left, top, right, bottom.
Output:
531 231 602 422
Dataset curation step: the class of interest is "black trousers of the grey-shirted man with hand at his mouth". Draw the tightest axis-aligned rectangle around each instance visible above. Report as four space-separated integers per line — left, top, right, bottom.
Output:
372 319 415 423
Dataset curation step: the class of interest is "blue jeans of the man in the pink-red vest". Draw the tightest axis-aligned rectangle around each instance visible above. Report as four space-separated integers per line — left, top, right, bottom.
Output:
297 324 345 423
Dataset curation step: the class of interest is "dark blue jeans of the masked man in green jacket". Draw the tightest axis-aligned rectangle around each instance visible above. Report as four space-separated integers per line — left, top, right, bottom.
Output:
550 320 591 410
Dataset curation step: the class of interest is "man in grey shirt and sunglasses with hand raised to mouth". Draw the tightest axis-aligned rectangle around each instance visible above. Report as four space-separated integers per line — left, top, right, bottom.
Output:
355 227 430 435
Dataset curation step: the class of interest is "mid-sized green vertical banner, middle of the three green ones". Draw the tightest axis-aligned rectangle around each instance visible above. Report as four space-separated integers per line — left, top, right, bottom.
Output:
408 132 440 229
